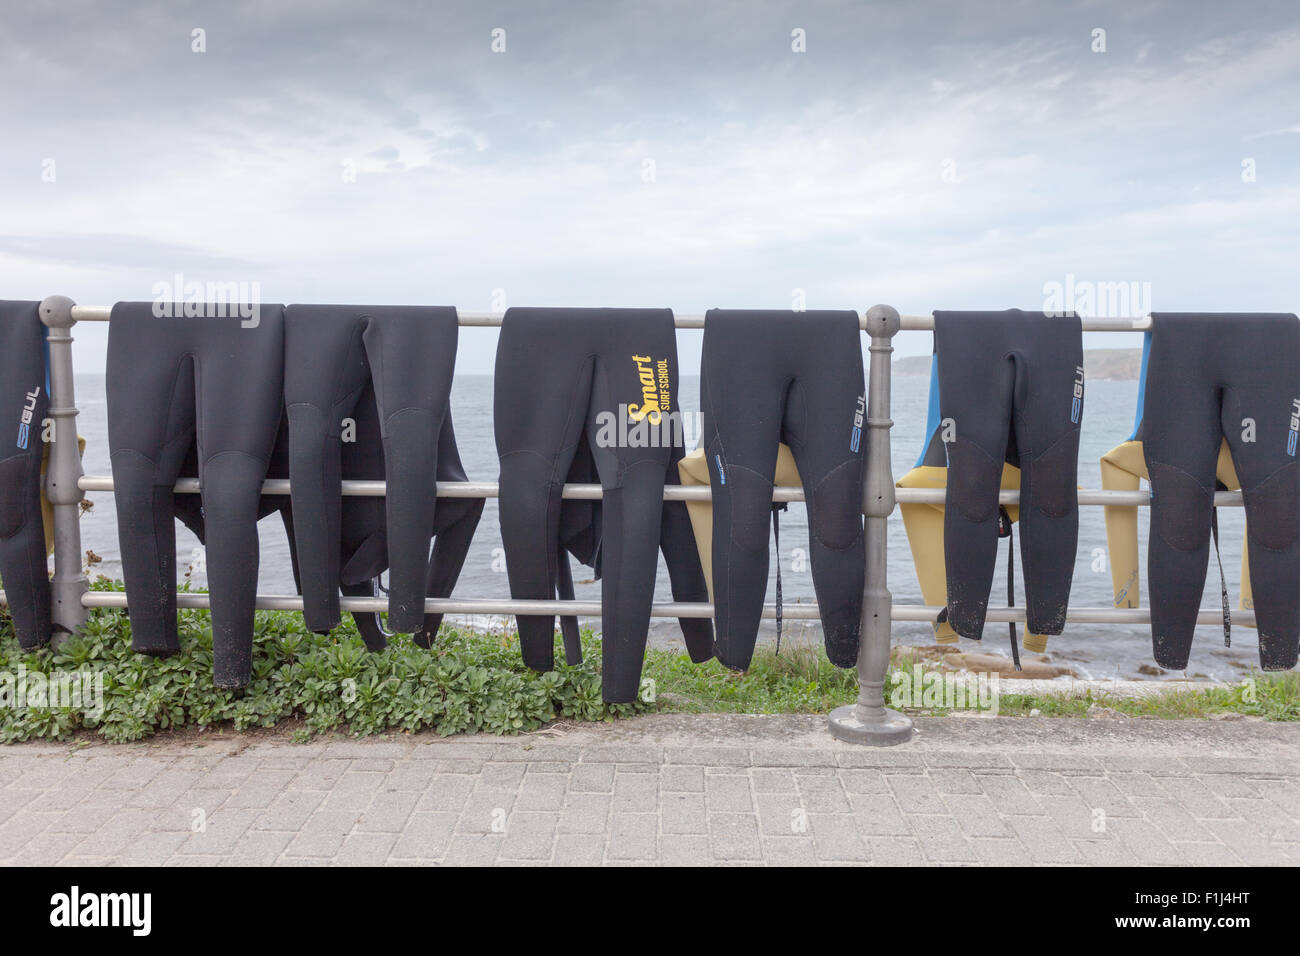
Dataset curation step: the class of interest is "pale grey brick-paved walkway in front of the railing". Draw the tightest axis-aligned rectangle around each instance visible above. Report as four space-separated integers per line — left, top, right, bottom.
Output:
0 715 1300 865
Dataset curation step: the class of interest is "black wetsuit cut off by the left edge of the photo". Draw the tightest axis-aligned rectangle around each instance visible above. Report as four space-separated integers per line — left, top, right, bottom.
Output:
0 302 51 650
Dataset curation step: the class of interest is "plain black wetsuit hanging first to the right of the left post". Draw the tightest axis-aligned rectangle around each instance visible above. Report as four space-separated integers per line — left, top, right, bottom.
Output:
105 302 285 687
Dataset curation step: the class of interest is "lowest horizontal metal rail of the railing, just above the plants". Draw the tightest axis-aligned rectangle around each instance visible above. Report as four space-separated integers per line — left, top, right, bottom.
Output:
68 591 1255 626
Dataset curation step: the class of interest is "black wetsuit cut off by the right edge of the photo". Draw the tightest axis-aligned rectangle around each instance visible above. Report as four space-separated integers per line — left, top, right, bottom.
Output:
1138 312 1300 670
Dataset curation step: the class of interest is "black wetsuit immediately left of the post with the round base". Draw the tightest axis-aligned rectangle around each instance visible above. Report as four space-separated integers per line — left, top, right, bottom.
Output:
699 310 866 670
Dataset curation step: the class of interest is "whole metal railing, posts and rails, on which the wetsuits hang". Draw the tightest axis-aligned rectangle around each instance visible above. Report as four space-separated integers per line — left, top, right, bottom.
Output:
20 295 1211 745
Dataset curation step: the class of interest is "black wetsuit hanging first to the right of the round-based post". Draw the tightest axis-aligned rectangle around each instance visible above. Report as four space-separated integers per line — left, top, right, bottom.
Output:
935 310 1083 640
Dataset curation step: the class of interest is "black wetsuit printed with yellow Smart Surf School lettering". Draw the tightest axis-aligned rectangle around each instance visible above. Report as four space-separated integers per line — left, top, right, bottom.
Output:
493 308 712 702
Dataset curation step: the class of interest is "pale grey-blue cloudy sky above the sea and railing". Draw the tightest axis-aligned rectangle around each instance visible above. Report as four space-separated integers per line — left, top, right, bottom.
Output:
0 0 1300 372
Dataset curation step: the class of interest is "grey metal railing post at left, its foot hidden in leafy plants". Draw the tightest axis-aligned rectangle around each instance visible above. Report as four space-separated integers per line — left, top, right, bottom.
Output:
40 295 88 643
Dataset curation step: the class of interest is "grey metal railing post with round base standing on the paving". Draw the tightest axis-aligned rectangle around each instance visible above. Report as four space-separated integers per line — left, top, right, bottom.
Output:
829 306 911 747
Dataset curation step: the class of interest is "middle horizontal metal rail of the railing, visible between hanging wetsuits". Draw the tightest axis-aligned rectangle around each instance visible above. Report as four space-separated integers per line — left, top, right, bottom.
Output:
78 475 1242 507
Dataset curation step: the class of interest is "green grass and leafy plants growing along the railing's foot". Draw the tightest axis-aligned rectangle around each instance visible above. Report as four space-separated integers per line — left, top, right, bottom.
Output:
0 581 1300 743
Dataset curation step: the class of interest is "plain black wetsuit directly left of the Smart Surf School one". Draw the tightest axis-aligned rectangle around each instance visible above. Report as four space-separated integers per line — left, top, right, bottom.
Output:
285 306 484 649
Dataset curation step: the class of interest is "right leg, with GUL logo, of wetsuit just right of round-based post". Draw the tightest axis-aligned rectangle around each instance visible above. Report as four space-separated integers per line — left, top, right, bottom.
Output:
1014 316 1084 635
